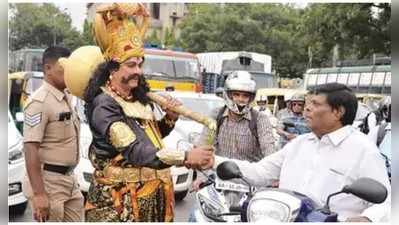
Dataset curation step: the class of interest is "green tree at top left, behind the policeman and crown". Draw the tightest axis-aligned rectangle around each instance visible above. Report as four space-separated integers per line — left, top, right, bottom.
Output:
9 3 84 50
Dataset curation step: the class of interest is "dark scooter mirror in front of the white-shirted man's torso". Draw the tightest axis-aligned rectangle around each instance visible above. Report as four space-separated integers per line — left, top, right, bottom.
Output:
342 177 388 204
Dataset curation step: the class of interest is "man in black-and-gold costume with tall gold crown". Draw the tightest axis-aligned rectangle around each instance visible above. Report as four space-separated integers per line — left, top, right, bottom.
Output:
63 3 213 222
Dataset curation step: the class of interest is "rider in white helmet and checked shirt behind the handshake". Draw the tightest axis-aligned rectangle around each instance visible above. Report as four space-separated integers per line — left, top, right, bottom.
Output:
191 71 275 221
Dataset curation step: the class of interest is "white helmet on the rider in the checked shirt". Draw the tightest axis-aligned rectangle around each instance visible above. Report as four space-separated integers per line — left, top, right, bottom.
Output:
223 71 256 115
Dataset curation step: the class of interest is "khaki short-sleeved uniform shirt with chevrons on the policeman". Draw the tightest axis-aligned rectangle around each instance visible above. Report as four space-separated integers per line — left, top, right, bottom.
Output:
24 81 80 166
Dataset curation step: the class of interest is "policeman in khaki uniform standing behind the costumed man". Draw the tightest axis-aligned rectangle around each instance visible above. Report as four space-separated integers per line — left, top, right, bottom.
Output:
22 46 84 222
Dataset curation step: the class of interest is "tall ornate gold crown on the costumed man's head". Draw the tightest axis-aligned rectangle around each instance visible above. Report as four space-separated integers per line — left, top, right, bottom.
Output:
94 3 150 63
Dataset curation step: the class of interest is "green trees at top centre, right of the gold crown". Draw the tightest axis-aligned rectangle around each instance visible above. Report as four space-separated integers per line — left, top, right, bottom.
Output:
181 4 307 77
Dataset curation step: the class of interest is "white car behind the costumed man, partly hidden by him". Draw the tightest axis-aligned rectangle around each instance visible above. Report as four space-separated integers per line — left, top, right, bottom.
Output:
75 92 224 201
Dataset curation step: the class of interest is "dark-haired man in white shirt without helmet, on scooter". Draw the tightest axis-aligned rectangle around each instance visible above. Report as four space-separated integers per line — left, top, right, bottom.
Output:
214 83 391 222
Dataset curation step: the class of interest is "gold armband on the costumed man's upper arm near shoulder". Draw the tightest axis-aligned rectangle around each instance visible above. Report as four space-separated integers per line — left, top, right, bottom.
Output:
109 122 136 150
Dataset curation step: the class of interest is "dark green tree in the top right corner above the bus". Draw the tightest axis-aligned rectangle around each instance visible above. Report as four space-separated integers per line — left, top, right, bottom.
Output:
302 3 391 66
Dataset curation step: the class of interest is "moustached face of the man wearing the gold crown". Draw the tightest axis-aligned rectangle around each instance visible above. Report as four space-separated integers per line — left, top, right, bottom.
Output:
112 57 143 90
